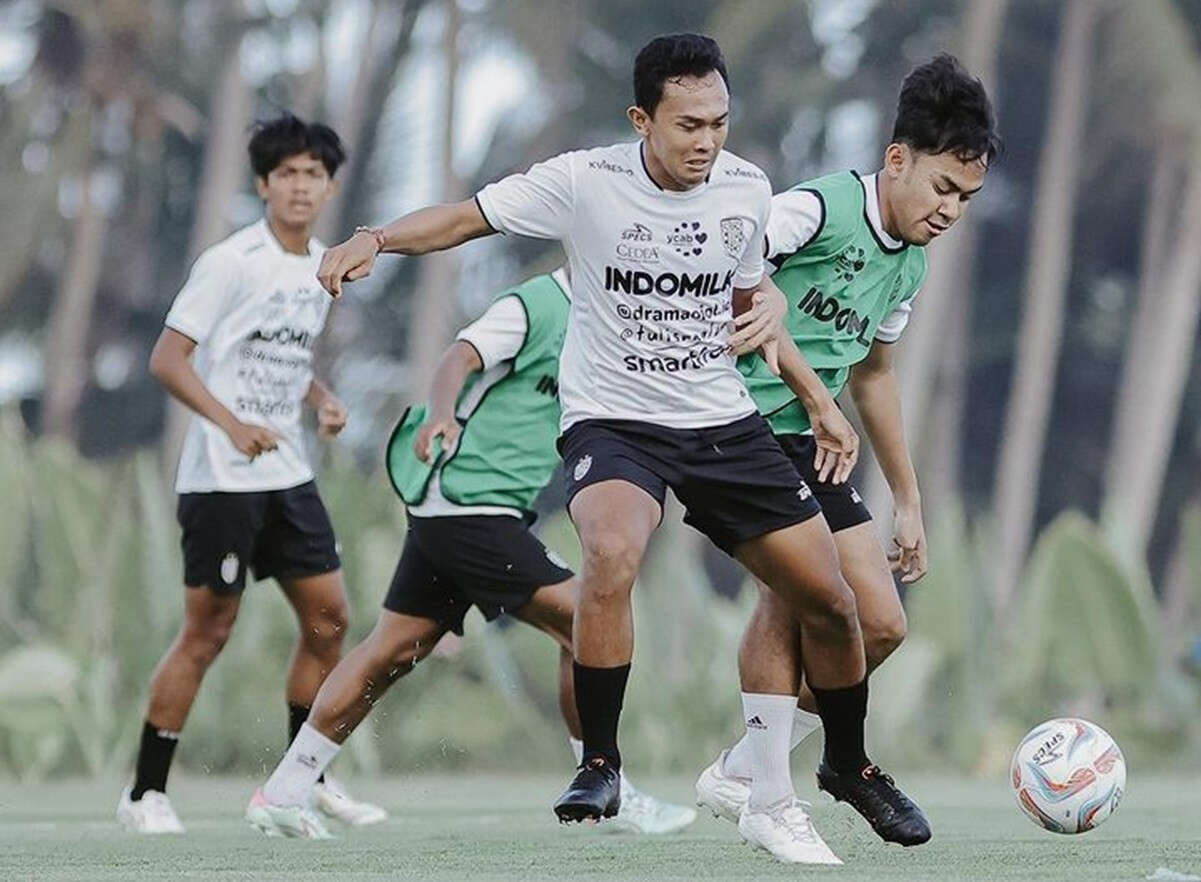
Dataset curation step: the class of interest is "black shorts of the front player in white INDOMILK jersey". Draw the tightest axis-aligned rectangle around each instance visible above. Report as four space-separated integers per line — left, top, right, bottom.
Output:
558 413 821 554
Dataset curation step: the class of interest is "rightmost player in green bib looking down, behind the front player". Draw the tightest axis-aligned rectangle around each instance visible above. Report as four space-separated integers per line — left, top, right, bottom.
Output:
697 55 999 845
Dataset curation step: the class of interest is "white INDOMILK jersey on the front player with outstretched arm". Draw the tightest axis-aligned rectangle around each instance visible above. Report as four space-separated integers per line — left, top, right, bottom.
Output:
476 142 771 429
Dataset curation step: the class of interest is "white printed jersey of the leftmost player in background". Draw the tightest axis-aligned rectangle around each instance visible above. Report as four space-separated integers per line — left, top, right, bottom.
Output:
166 220 330 493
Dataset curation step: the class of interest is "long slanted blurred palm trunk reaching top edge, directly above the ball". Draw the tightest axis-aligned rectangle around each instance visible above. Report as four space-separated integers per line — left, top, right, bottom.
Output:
993 0 1098 609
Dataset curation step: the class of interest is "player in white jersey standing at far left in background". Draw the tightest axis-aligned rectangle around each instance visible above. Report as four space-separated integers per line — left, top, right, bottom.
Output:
116 115 386 833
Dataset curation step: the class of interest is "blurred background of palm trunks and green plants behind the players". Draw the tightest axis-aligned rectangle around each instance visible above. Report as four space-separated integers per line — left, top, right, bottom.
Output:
0 0 1201 776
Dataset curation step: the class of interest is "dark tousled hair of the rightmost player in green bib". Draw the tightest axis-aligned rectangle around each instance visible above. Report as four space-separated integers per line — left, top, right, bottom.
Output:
892 53 1002 163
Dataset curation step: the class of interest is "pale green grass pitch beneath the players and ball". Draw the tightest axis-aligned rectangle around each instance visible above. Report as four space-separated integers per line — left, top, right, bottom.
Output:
0 774 1201 882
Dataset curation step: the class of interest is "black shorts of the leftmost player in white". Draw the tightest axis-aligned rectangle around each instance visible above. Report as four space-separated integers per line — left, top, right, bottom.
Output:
175 481 342 592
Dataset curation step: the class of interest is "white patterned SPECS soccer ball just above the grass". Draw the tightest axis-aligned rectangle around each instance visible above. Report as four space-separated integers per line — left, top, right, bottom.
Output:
1010 719 1125 833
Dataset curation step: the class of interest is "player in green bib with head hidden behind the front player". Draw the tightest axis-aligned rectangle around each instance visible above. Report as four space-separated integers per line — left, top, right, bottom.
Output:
246 270 697 839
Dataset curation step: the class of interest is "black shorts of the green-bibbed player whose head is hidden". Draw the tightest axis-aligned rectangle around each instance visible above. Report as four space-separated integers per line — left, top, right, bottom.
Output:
383 514 572 634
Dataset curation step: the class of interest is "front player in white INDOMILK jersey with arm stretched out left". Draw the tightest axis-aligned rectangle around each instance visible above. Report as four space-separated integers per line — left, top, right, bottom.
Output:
307 34 917 863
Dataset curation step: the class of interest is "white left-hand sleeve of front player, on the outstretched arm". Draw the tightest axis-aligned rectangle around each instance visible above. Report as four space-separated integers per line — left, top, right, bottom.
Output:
476 153 575 239
